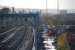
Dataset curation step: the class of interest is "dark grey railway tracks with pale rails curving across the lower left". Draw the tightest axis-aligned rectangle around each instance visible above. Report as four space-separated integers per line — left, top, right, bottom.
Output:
0 26 32 50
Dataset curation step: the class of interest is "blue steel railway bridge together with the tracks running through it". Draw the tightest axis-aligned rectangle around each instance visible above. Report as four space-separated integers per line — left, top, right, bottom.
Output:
0 13 39 50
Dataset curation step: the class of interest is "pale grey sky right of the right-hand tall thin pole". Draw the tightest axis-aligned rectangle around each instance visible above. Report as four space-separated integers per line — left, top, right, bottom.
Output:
59 0 75 9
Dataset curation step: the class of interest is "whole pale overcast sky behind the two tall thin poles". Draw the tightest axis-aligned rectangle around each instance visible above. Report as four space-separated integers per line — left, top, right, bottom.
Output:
0 0 75 9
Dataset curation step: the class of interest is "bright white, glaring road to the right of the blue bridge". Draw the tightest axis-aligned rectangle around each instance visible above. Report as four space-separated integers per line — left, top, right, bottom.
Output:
42 28 56 50
